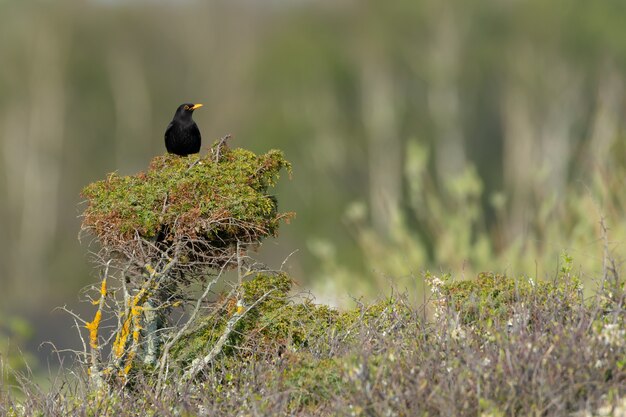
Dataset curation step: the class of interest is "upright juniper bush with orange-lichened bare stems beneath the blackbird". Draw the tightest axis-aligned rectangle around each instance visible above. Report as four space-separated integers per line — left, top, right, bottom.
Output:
75 141 292 386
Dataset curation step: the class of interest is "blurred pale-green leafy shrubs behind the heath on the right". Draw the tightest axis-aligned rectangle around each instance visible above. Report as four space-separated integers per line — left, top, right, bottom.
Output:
311 142 626 294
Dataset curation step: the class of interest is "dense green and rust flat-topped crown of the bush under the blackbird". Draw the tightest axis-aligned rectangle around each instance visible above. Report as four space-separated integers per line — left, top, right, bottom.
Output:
82 145 291 257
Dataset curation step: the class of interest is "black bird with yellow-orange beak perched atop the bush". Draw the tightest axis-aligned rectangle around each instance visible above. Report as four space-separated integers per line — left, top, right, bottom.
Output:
165 103 202 156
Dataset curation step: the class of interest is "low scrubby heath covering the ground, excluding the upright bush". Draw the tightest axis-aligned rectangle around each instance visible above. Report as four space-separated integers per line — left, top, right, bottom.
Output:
0 264 626 416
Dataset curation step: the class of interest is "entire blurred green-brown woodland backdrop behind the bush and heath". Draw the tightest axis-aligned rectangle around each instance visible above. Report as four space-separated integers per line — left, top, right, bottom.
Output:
0 0 626 374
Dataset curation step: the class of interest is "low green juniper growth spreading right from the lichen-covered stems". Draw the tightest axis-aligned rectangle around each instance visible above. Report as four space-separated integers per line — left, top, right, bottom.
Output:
171 273 411 367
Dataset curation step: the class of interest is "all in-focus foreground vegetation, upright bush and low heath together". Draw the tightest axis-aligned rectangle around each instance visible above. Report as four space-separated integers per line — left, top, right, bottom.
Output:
0 142 626 417
